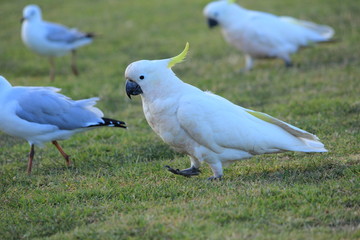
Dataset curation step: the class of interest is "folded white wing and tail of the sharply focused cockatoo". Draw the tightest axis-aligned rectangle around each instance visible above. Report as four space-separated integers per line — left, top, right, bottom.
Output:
177 93 326 154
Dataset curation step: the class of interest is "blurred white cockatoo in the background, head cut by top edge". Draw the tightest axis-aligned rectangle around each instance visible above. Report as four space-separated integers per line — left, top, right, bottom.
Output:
204 0 335 71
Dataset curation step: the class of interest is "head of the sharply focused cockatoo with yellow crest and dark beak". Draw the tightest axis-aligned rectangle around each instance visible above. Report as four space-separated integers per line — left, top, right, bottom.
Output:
125 43 189 99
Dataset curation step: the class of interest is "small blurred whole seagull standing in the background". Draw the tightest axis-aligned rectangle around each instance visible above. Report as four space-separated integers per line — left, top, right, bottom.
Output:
21 5 94 80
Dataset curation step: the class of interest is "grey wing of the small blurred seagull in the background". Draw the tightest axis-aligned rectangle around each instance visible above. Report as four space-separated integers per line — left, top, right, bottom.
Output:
45 22 88 43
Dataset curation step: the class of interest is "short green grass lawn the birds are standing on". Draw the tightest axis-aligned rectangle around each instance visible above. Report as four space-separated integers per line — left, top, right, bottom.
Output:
0 0 360 240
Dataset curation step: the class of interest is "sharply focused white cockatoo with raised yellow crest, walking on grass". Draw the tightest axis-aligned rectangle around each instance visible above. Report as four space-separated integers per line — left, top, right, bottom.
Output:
125 44 327 179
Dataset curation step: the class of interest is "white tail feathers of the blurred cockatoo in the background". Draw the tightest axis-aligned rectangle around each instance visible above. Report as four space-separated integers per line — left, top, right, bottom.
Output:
280 16 335 39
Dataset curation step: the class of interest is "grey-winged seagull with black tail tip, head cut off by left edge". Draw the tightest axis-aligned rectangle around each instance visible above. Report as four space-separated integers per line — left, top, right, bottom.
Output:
0 76 126 174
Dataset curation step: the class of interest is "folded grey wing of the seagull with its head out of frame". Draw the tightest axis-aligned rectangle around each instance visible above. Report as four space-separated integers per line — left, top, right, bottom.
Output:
16 87 103 130
